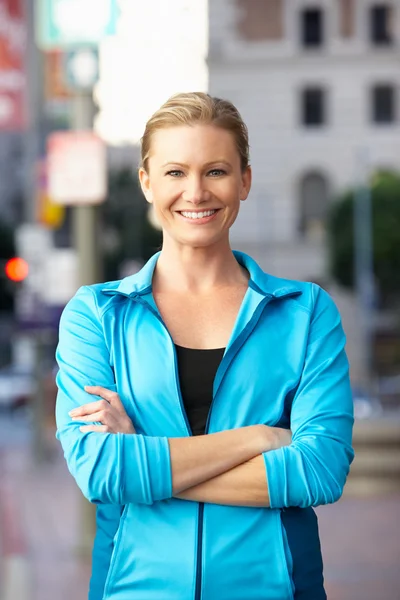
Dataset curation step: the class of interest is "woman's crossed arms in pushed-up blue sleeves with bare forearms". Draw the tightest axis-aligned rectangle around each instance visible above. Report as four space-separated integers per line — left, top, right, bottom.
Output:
56 288 353 508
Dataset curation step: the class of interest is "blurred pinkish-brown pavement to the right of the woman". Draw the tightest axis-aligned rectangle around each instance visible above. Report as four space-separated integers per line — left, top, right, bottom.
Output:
317 494 400 600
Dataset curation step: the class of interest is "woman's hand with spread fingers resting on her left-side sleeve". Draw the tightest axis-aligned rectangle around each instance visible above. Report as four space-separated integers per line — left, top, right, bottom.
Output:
69 385 136 433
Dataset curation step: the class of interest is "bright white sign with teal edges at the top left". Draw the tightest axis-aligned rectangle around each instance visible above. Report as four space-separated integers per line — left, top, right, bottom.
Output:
36 0 118 50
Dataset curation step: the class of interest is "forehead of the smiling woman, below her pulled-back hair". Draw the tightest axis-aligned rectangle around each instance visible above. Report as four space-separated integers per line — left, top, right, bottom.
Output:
150 124 240 164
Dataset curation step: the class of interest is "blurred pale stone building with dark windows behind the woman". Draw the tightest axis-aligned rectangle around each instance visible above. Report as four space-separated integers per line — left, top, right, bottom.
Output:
208 0 400 380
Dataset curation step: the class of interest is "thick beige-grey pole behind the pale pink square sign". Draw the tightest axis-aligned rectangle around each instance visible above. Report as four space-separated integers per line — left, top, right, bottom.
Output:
72 91 101 559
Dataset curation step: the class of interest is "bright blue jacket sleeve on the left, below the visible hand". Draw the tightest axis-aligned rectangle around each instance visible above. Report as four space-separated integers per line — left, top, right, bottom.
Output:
56 287 172 504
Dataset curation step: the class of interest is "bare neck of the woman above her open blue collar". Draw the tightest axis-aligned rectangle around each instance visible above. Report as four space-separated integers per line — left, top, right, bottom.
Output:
153 239 248 294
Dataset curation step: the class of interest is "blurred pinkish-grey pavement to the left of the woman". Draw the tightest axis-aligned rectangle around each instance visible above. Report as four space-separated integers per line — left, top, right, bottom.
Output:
0 440 90 600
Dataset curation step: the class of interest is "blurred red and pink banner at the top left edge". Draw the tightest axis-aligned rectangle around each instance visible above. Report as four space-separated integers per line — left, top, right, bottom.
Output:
0 0 26 131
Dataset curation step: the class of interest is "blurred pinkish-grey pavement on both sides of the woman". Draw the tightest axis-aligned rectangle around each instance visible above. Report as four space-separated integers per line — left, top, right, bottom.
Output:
0 436 400 600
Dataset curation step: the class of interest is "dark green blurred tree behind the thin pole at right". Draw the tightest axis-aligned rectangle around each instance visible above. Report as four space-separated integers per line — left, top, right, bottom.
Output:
328 171 400 308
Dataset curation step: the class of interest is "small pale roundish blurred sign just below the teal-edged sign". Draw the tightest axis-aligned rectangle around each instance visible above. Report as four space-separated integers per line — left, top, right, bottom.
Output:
64 48 99 91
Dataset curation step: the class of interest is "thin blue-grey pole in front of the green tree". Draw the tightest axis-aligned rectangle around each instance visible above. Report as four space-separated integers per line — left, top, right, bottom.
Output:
354 149 374 390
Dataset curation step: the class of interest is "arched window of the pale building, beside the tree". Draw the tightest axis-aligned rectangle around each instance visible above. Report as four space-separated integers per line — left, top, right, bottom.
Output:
299 172 329 241
